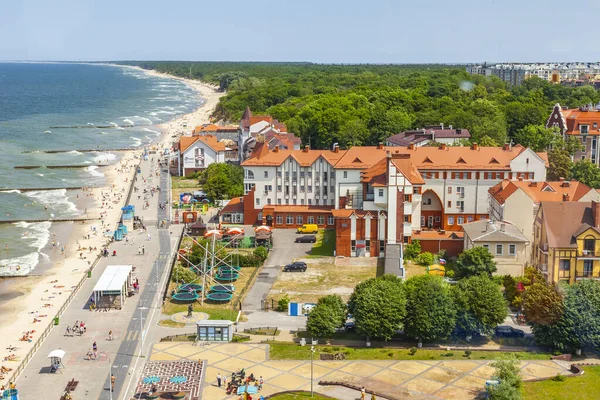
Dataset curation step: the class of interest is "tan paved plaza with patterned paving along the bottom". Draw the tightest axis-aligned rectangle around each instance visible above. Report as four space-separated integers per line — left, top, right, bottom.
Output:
150 342 571 400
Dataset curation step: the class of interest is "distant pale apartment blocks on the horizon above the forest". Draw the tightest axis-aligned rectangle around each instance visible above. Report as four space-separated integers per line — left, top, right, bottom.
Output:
466 62 600 86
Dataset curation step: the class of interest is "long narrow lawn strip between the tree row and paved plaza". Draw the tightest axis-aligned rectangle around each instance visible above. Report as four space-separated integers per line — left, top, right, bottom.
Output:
269 342 550 360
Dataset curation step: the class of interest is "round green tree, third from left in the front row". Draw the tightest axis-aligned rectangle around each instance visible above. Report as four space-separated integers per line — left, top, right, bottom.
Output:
404 275 456 341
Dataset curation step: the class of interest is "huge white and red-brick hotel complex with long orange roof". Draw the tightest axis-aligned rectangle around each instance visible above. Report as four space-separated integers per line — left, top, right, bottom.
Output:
242 143 547 257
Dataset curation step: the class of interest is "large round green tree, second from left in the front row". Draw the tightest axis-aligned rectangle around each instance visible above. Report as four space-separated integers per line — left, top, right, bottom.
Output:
348 275 406 340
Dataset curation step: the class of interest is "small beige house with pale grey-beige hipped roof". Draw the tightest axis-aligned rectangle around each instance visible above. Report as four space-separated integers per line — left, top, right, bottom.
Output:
463 220 530 276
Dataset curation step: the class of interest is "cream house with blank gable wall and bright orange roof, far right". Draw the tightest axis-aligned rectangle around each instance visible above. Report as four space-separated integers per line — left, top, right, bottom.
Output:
488 179 600 262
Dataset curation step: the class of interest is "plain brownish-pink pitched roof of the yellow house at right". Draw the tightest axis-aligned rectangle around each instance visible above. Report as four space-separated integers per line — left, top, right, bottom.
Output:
540 201 594 248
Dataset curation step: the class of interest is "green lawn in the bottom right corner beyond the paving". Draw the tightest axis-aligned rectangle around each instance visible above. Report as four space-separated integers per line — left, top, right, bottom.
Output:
523 366 600 400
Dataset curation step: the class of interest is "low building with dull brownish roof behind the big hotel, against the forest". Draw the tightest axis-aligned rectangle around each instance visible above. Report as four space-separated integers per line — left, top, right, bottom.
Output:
385 124 471 147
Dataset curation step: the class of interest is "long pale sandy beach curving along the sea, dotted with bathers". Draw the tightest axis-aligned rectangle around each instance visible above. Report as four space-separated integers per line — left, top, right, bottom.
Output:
0 67 223 385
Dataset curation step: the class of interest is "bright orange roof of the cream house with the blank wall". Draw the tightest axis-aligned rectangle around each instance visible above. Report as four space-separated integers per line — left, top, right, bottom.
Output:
488 179 593 204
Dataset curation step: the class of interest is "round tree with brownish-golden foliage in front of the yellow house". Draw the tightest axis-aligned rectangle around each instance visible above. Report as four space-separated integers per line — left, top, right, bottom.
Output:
522 281 563 325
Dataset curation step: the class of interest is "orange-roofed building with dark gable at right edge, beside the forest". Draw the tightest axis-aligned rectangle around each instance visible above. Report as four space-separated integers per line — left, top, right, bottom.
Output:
546 103 600 164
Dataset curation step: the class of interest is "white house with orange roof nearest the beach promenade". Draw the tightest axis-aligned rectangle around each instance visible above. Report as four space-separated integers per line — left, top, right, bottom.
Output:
173 135 231 176
